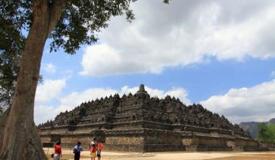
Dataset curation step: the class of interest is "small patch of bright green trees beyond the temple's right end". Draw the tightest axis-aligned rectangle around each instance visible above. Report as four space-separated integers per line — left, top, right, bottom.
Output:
257 123 275 143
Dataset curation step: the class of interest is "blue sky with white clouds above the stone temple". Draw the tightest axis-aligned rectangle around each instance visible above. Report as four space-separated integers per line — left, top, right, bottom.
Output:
35 0 275 124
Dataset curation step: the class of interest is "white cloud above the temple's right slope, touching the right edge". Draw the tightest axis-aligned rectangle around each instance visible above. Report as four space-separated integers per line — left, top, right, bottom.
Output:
201 80 275 122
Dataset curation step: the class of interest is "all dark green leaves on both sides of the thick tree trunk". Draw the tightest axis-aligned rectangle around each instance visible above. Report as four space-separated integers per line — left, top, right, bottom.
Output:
0 0 170 109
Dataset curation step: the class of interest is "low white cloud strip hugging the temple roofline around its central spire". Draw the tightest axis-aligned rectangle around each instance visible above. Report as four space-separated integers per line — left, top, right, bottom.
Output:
35 86 191 124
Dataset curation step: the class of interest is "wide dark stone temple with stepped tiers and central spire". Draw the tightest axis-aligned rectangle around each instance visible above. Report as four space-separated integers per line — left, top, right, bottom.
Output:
38 85 260 152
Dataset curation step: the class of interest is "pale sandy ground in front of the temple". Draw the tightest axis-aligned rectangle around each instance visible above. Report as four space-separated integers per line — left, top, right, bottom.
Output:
45 149 275 160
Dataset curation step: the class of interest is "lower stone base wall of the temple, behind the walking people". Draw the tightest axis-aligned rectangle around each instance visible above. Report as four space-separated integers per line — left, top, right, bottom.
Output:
41 125 263 152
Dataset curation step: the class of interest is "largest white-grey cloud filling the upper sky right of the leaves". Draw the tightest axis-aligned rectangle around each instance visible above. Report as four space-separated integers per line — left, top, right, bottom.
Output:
81 0 275 76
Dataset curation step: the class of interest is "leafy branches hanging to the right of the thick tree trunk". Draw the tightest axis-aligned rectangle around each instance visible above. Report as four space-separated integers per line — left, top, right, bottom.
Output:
50 0 134 54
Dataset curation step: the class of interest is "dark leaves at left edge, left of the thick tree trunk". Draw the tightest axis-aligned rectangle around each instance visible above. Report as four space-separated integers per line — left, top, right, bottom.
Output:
0 0 26 106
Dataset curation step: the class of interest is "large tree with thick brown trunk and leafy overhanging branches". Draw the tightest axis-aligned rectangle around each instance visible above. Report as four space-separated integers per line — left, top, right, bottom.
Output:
0 0 167 160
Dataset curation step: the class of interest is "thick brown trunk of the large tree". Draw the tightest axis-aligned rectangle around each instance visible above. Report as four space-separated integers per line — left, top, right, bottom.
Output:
0 0 65 160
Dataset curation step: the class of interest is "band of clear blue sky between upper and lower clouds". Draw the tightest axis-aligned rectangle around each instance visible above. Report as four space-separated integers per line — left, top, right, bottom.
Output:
42 50 275 103
